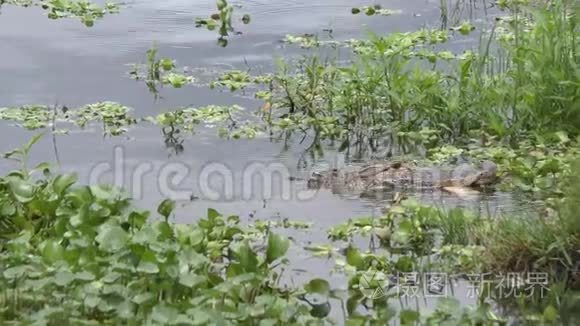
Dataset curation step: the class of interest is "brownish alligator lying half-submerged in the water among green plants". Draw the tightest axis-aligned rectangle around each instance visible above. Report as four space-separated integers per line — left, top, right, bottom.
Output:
307 161 497 197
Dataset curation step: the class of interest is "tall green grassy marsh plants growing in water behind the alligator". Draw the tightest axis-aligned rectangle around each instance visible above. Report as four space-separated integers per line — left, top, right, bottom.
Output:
204 1 580 156
